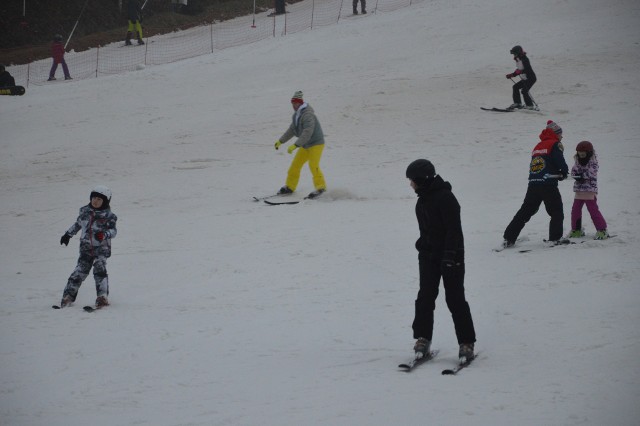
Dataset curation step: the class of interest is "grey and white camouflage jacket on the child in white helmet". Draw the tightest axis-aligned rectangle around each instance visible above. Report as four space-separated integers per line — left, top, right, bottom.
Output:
67 205 118 257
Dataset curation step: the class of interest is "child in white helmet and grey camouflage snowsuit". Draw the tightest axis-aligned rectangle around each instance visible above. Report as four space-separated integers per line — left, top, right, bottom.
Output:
60 185 118 308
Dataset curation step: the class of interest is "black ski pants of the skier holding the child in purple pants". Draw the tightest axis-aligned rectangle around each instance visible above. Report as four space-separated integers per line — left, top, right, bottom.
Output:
504 185 564 241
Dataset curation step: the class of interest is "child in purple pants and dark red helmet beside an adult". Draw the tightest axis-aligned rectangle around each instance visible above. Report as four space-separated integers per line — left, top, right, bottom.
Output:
569 141 609 240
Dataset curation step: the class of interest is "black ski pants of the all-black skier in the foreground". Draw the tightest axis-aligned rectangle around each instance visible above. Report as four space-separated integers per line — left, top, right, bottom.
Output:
412 256 476 344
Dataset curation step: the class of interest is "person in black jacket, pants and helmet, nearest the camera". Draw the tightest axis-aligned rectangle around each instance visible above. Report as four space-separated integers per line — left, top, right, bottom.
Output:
406 159 476 362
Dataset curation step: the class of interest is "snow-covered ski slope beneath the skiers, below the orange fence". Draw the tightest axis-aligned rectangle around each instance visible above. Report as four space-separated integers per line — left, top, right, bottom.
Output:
0 0 640 426
